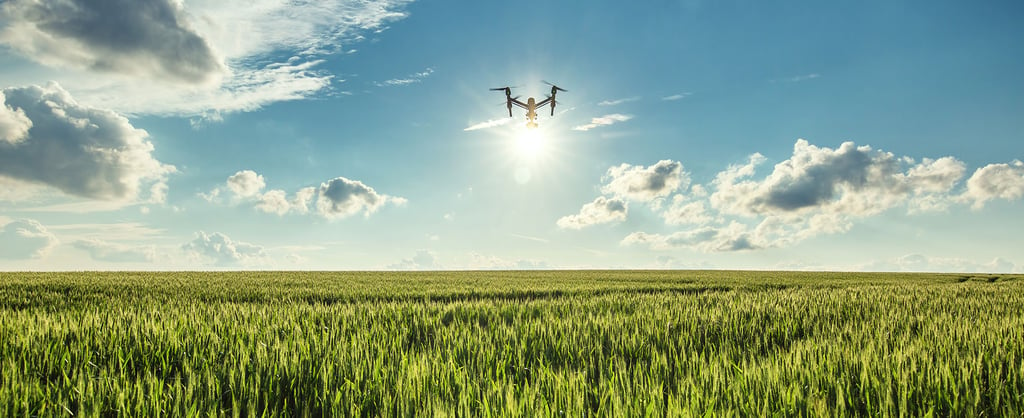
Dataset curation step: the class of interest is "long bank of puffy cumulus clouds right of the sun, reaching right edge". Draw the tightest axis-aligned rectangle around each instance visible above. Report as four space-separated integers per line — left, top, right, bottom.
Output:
558 139 1024 252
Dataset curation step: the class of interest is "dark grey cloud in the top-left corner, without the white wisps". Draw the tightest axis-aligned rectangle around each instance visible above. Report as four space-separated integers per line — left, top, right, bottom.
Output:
0 0 225 84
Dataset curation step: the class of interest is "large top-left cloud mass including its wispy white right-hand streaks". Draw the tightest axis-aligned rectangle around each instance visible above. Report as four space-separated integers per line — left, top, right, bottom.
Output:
0 0 415 116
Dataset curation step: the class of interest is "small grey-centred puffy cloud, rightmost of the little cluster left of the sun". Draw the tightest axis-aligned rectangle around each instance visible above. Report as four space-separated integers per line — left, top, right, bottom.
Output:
316 177 406 219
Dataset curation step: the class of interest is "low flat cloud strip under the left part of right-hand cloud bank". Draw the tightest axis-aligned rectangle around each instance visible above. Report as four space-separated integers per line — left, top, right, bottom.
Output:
620 221 761 252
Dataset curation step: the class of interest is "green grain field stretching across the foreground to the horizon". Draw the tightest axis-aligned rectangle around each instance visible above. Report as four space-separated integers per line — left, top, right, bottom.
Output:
0 271 1024 417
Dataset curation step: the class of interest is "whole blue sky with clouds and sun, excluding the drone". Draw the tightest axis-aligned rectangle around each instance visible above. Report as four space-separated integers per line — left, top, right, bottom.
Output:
0 0 1024 273
